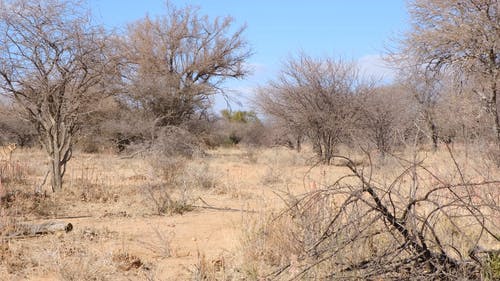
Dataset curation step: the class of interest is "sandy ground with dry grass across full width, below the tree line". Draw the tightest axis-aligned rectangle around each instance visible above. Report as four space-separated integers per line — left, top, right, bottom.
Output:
0 143 500 280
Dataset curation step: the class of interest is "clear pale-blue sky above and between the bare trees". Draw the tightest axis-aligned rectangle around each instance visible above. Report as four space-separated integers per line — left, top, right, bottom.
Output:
90 0 408 109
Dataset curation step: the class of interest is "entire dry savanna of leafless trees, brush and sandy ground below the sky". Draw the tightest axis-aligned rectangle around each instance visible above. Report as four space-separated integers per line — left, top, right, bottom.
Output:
0 0 500 281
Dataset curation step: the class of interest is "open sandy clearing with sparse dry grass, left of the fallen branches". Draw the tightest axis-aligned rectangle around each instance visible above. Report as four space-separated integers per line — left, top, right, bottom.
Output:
0 145 332 280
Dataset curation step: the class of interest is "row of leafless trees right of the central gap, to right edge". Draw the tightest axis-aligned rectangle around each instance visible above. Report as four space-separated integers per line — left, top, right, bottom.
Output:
256 0 500 164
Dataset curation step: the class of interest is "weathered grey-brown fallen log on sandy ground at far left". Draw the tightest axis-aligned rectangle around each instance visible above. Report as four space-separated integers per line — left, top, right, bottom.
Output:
1 221 73 238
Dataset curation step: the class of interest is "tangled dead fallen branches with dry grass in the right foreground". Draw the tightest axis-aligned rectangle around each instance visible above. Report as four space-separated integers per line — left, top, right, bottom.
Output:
238 152 500 280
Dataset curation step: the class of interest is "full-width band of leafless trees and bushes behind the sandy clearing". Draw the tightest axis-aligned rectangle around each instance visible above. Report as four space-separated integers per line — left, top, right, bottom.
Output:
0 0 500 190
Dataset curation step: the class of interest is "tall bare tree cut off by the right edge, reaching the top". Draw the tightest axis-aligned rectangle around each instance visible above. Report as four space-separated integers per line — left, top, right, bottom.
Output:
402 0 500 147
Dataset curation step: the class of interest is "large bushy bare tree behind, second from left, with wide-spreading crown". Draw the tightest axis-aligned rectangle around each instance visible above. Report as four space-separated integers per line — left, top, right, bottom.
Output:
123 2 251 129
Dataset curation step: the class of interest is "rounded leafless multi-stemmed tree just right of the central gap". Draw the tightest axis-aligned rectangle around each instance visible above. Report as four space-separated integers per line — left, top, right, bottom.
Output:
256 54 371 163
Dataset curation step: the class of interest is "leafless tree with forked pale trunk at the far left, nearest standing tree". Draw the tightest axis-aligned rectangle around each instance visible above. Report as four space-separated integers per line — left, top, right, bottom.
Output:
0 0 119 191
